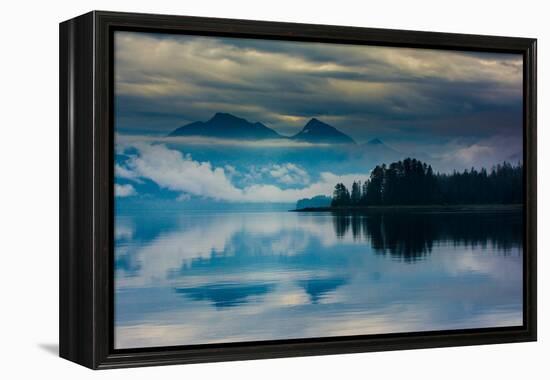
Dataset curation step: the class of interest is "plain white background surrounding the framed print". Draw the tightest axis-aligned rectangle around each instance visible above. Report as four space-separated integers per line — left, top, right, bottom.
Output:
0 0 550 380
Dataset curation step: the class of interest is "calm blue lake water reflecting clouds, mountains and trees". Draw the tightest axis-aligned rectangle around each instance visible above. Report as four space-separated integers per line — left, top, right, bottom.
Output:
115 211 522 348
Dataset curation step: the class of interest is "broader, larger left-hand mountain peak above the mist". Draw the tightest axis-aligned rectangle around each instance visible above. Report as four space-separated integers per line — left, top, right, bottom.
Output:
168 112 283 140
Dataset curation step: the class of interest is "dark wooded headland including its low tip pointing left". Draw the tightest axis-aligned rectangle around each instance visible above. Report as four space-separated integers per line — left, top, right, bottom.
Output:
294 158 523 212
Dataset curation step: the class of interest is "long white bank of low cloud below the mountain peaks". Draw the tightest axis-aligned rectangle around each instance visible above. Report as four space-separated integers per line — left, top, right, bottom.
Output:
119 143 368 203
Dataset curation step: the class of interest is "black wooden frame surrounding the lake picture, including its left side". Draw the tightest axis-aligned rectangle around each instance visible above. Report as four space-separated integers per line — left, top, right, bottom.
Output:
59 11 537 369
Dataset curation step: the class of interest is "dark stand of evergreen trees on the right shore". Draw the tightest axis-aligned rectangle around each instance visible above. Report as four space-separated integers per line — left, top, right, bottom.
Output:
331 158 523 208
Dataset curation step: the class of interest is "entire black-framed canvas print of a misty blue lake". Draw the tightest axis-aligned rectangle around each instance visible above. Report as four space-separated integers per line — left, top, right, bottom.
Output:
60 12 536 368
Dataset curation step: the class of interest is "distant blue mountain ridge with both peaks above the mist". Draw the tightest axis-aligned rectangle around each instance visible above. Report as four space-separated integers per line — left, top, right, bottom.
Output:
168 112 355 144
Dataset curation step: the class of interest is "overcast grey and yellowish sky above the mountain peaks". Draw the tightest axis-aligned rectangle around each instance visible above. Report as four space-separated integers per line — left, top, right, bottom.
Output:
115 32 522 160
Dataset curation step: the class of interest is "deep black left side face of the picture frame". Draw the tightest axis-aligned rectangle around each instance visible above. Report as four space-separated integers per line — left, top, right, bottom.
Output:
59 13 95 368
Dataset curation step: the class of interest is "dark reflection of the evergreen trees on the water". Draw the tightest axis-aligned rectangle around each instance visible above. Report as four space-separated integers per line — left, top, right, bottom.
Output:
332 212 522 262
